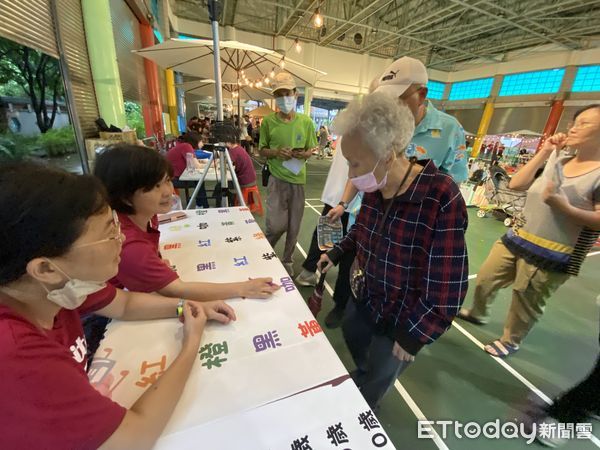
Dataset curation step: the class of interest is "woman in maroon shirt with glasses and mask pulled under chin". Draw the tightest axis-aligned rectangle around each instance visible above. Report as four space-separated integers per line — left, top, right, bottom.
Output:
0 163 235 450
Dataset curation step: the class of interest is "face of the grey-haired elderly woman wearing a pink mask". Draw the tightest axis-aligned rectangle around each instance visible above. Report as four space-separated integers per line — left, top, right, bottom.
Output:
342 128 393 182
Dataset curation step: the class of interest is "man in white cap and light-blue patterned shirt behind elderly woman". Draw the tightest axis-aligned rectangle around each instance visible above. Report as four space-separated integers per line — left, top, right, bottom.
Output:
296 56 468 328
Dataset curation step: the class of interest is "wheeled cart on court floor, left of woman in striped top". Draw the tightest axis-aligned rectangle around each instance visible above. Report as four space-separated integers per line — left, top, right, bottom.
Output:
477 169 527 227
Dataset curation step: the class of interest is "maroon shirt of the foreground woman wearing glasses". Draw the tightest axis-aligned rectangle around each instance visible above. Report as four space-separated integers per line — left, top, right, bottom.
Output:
0 285 127 450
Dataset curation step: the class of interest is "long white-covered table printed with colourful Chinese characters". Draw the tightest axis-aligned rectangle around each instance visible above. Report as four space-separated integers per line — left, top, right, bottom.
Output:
89 208 394 450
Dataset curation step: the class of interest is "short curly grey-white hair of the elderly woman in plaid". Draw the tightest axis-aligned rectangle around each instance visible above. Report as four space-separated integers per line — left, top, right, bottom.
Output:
333 92 415 158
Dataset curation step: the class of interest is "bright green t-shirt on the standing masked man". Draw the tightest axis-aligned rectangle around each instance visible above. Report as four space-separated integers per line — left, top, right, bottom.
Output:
259 113 317 184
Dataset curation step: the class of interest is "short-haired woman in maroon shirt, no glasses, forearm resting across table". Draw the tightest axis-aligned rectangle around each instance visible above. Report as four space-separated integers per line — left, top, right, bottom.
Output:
95 144 279 301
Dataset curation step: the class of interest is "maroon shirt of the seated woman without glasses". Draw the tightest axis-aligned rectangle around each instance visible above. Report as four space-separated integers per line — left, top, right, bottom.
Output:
110 213 179 292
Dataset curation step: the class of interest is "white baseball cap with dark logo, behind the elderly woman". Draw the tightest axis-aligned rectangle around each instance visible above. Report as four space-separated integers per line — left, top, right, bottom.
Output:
371 56 429 97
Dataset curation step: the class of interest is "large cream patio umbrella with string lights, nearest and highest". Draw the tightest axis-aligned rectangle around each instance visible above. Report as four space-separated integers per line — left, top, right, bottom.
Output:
133 39 326 88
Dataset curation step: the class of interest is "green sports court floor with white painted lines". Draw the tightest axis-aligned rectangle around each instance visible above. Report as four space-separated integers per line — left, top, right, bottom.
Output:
226 156 600 450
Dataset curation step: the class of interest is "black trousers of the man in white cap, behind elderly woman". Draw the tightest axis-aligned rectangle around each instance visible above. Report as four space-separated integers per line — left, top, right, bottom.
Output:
302 205 356 308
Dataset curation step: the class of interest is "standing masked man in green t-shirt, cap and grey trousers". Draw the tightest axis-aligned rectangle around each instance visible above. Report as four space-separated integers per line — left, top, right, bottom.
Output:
259 72 317 276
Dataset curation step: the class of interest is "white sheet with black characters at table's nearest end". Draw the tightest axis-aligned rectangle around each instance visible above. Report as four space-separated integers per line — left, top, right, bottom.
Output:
156 379 395 450
